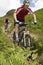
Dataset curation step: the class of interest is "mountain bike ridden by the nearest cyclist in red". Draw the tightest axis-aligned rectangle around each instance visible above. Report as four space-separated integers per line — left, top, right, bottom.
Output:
13 23 32 47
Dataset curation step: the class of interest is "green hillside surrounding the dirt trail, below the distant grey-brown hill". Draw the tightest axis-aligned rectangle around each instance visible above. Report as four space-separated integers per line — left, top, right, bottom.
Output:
0 9 43 65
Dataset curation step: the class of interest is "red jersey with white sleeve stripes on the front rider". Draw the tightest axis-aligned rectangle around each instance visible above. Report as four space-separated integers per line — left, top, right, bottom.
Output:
16 5 34 21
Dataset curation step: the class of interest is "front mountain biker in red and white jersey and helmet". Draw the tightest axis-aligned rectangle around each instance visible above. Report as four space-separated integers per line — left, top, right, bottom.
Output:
14 0 37 41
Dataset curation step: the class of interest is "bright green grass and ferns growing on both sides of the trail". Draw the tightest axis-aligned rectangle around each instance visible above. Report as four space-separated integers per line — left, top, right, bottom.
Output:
0 9 43 65
